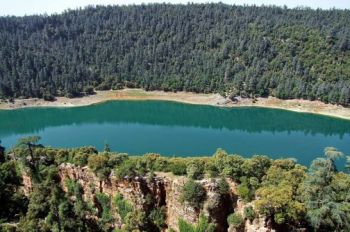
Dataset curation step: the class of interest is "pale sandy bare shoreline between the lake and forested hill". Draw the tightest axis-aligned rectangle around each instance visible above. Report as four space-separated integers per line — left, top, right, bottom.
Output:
0 89 350 120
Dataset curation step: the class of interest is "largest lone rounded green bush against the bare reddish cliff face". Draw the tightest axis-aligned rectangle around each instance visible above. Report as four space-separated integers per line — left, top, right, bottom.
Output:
181 180 206 209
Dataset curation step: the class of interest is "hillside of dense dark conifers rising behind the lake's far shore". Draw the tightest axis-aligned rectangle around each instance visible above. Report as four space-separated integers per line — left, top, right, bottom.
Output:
0 4 350 105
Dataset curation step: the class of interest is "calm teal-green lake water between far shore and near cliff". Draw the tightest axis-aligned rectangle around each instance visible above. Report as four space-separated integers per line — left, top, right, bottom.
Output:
0 101 350 165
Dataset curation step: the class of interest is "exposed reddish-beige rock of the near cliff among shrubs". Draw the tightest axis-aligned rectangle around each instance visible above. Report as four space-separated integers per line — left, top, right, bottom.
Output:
23 164 273 232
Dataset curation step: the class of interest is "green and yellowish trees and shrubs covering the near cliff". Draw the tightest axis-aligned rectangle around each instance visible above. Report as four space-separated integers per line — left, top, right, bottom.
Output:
0 137 350 232
